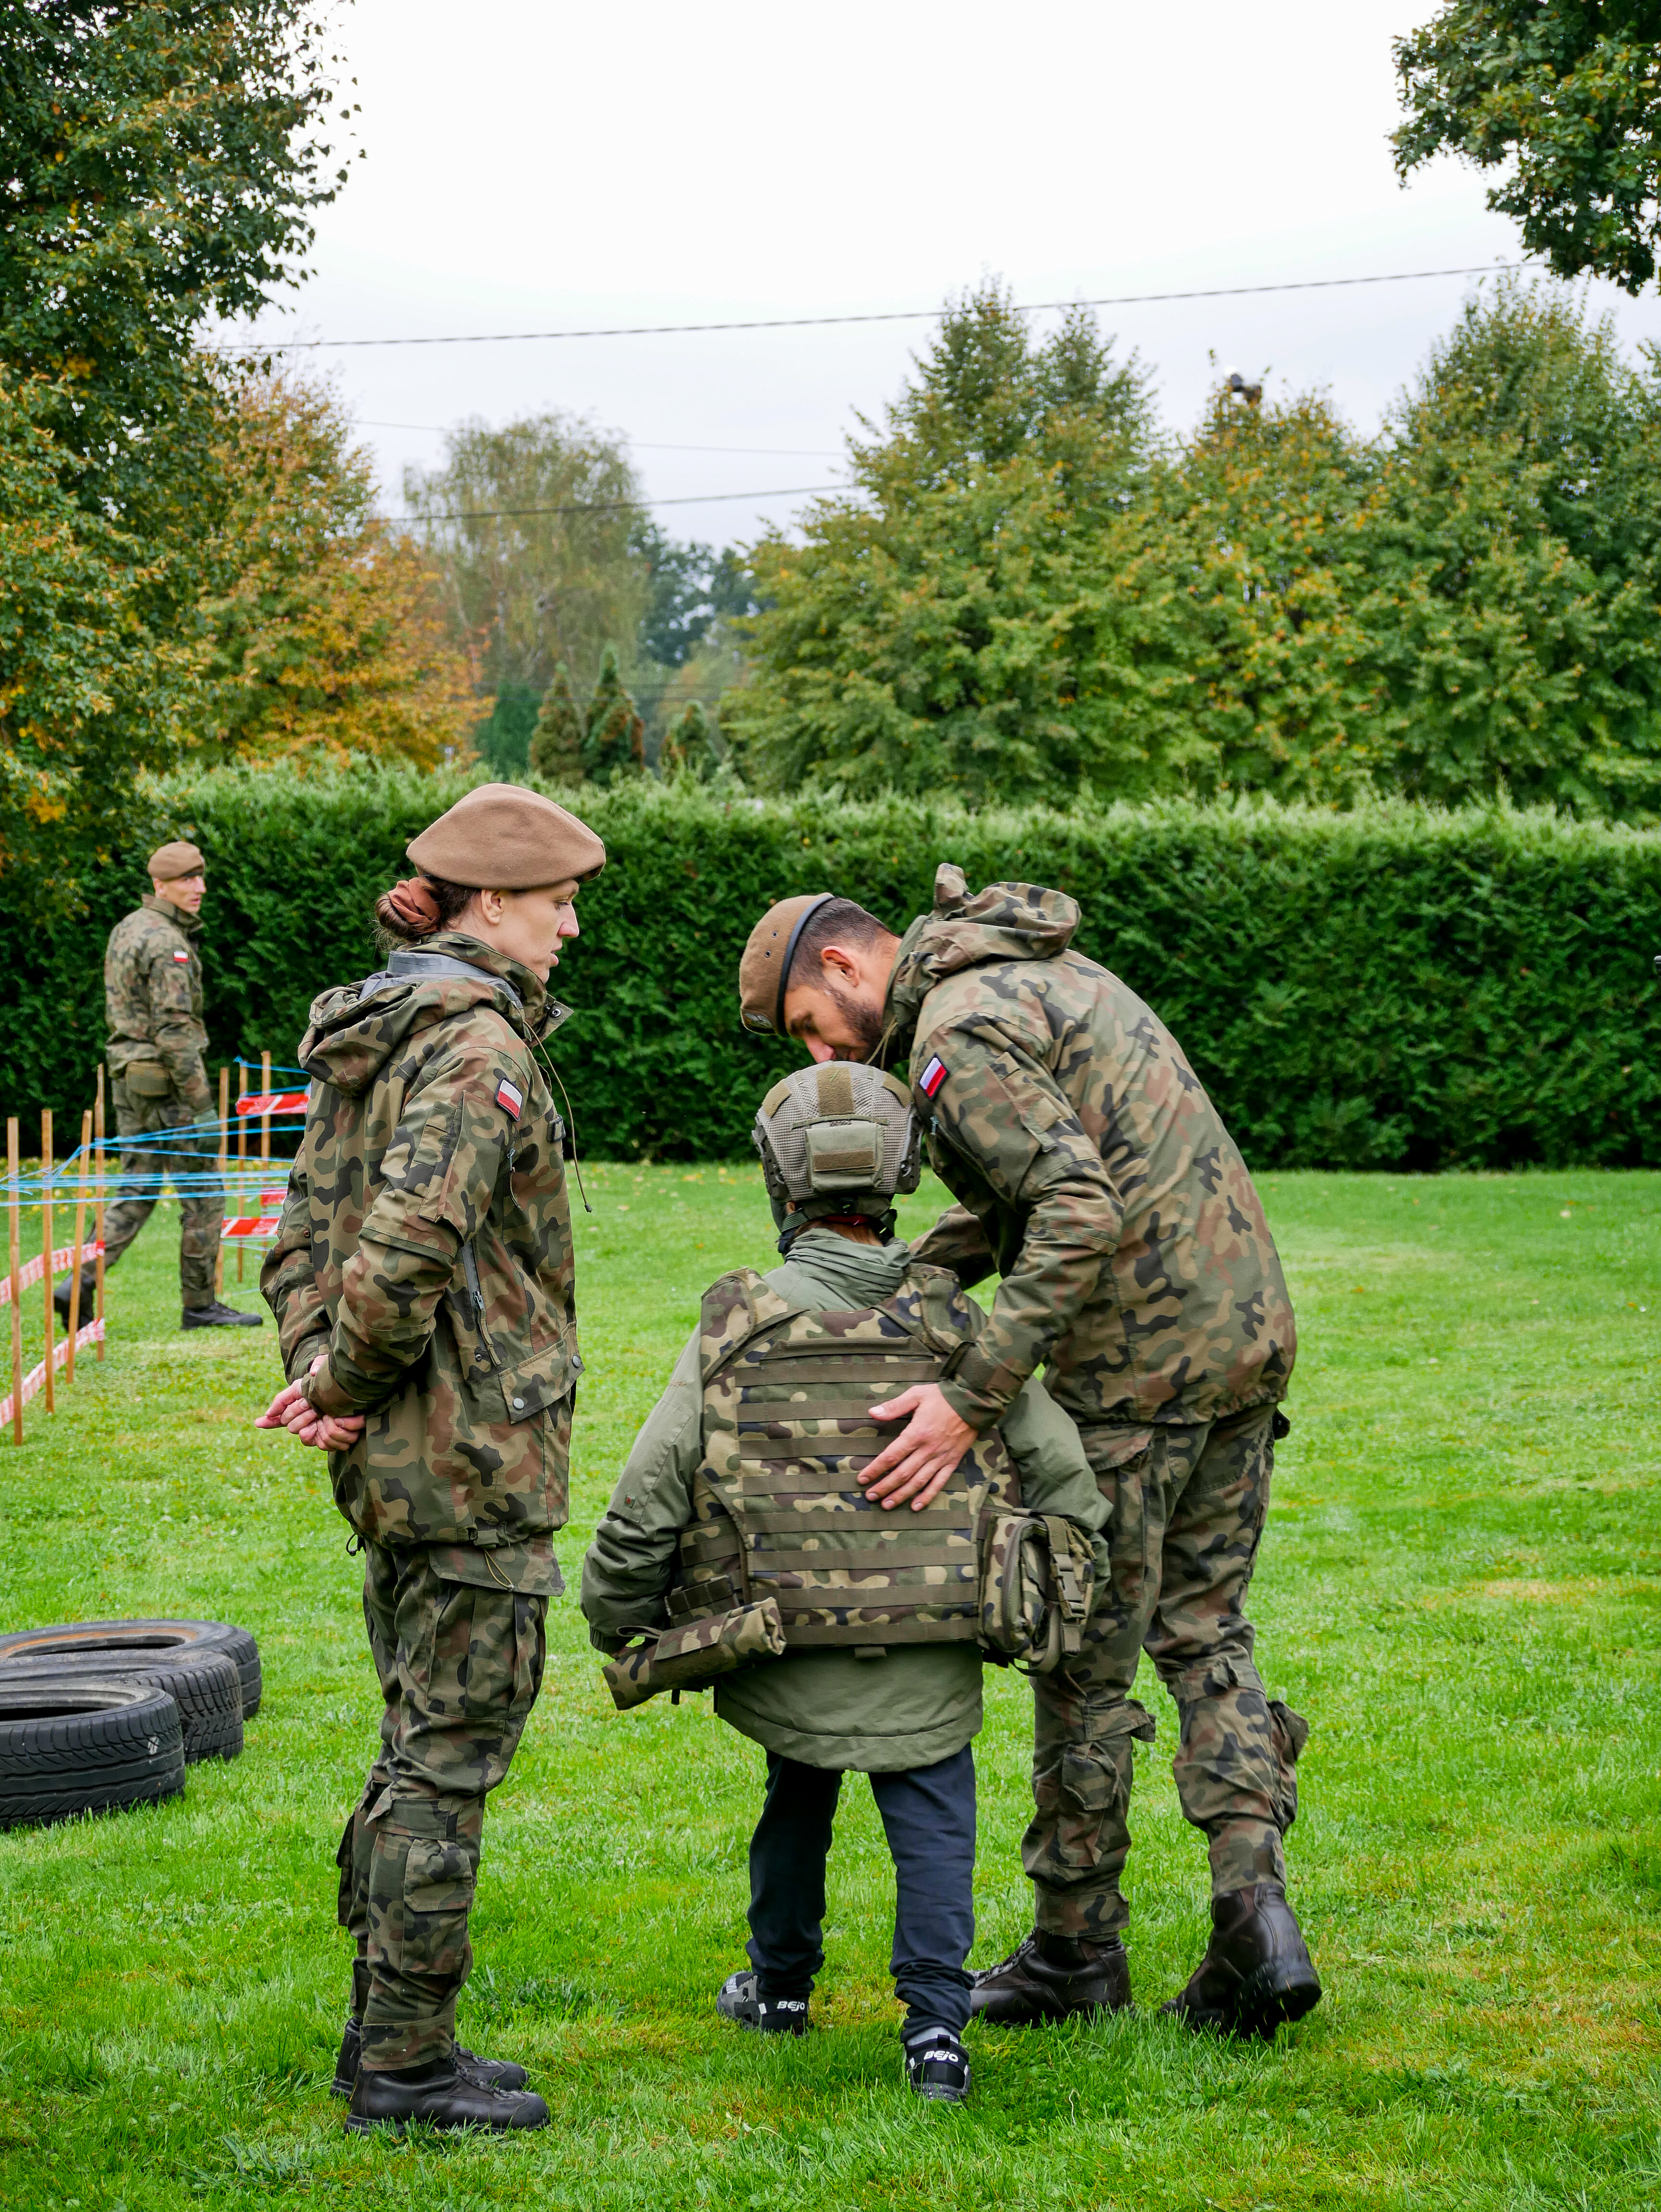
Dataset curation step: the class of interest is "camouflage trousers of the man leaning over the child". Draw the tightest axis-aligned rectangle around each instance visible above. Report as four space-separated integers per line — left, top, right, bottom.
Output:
1022 1407 1309 1938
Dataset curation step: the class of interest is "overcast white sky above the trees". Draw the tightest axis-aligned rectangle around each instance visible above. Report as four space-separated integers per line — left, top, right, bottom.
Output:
224 0 1661 542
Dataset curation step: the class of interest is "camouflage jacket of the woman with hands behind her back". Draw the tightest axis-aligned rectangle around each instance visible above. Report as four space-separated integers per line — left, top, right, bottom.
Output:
261 934 581 1591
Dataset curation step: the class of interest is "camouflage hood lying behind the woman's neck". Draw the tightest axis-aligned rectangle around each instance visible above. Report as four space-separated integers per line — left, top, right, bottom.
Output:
301 931 571 1097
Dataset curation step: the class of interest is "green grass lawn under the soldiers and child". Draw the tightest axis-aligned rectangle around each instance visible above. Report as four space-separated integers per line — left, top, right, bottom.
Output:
0 1166 1661 2212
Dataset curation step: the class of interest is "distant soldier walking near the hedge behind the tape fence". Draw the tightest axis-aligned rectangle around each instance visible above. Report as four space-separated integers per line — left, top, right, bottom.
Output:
53 841 265 1330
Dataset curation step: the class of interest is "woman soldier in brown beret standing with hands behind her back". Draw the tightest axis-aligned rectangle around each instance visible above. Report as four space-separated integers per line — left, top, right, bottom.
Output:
259 783 606 2133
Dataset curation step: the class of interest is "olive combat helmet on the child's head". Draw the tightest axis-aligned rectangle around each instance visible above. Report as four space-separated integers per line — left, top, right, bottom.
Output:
750 1060 923 1252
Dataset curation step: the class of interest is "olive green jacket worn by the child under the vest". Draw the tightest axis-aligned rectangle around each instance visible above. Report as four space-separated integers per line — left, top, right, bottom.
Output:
581 1230 1108 1774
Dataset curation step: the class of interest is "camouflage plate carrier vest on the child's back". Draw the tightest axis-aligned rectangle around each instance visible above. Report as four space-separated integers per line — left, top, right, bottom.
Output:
668 1267 1020 1655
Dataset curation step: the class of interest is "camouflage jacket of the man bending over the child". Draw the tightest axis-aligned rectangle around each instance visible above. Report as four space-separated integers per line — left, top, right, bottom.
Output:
880 865 1296 1429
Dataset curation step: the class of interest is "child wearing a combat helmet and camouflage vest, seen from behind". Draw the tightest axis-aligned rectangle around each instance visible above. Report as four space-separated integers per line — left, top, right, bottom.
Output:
581 1066 1106 2101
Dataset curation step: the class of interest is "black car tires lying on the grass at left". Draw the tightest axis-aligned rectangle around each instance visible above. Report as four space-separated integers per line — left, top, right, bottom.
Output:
0 1621 263 1827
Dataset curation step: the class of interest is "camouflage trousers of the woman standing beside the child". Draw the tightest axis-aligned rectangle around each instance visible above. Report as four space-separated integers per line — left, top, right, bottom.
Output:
336 1544 549 2070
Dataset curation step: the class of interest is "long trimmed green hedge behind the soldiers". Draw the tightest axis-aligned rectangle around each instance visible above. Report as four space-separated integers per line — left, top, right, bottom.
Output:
0 767 1661 1170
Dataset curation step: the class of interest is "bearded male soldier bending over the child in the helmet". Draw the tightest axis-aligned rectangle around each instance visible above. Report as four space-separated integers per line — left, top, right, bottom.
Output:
738 867 1320 2035
